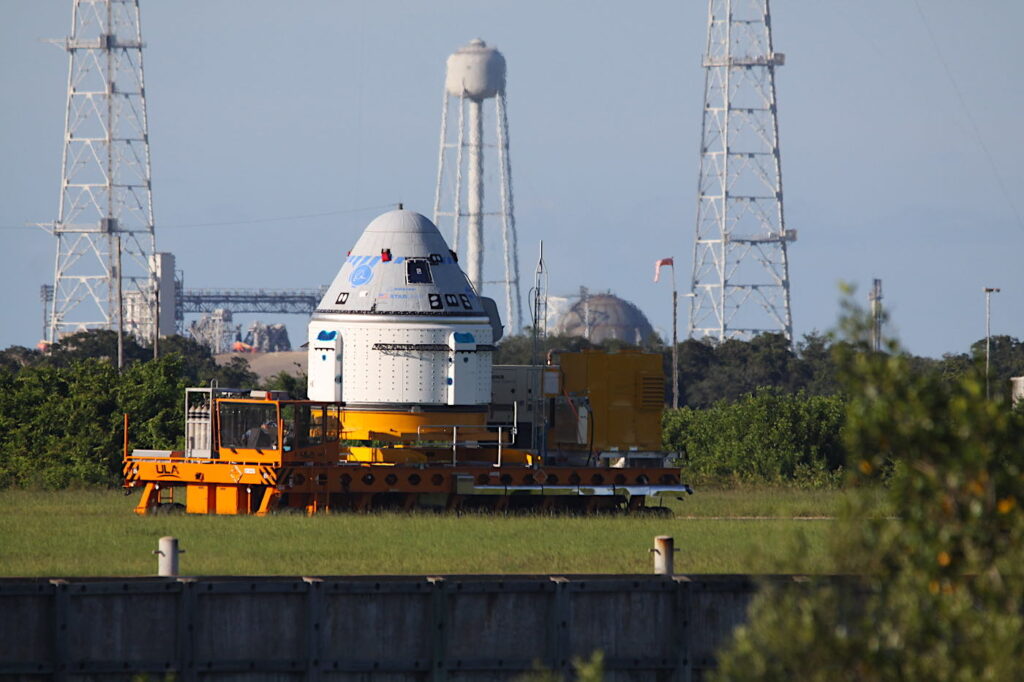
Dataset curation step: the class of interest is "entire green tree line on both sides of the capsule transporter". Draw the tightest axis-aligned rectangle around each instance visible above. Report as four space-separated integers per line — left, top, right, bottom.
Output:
0 331 1024 487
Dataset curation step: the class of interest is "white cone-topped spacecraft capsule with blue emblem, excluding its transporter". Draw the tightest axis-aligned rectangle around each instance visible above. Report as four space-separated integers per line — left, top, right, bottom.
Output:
308 209 502 436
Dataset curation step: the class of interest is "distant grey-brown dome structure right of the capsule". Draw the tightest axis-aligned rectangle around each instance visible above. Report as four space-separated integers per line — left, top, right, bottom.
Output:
556 293 654 345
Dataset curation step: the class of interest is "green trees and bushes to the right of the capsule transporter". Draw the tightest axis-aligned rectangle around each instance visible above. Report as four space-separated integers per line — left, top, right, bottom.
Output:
496 333 1024 485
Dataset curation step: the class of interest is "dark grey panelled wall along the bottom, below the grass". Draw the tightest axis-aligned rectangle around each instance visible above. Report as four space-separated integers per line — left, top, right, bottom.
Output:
0 576 774 682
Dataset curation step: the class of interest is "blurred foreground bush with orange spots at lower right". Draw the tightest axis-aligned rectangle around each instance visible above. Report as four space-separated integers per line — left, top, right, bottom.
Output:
718 301 1024 680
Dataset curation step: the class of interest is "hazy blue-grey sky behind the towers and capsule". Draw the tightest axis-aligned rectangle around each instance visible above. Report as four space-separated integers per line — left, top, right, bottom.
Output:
0 0 1024 356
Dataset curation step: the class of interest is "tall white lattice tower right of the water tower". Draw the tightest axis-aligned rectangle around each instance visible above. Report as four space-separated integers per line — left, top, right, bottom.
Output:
689 0 796 341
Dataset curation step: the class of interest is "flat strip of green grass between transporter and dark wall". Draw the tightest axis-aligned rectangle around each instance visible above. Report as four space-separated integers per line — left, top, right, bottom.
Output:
0 488 884 577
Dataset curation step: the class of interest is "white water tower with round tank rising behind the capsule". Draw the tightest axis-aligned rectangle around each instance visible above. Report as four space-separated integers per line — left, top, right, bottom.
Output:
434 39 522 334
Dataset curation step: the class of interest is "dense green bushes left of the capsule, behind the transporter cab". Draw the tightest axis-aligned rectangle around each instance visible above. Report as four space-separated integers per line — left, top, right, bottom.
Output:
0 331 257 488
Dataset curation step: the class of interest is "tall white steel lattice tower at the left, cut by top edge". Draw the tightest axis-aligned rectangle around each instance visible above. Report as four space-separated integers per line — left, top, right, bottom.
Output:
48 0 157 341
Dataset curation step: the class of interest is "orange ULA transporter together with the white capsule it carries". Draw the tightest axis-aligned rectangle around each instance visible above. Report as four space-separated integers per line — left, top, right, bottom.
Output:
124 210 690 515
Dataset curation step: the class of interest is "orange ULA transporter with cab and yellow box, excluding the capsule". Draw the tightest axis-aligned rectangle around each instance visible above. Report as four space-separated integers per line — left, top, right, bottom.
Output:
124 351 691 515
